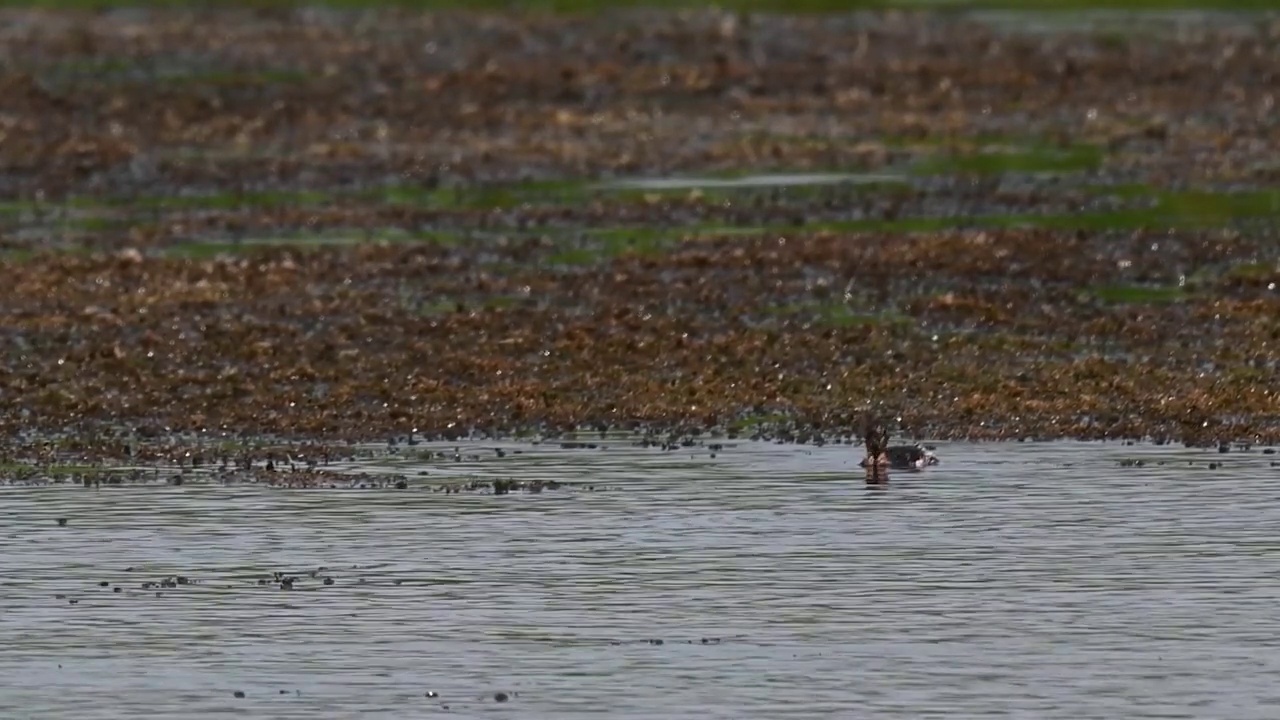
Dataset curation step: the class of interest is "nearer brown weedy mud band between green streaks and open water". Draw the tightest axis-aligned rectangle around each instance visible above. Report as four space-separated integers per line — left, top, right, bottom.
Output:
0 231 1280 451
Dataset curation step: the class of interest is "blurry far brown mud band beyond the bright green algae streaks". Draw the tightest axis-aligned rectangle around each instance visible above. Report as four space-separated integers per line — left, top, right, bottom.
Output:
0 9 1277 197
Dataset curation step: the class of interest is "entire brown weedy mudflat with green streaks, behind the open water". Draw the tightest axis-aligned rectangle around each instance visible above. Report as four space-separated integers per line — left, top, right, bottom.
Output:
0 9 1280 471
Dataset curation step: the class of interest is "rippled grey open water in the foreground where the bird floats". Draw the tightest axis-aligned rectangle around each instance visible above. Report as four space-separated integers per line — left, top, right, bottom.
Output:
0 442 1280 720
